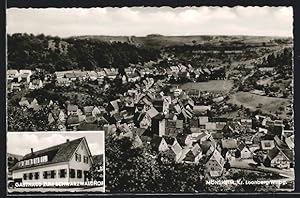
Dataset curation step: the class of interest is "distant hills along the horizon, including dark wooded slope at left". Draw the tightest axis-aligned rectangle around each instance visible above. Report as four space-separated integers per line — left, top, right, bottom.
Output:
7 33 292 72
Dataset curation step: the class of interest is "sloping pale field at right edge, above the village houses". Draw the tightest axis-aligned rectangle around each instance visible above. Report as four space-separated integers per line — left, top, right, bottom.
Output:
228 92 290 116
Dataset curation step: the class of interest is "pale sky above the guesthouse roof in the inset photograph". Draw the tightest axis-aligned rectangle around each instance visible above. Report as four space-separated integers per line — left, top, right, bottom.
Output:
7 131 104 155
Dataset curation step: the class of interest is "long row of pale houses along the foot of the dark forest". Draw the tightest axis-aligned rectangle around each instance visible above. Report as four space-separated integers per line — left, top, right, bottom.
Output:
55 65 225 86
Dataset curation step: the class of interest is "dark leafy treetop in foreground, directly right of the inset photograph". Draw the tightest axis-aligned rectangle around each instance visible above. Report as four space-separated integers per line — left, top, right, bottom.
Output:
105 135 160 192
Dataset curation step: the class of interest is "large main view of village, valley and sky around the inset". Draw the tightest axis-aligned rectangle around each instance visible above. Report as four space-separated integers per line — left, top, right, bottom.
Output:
7 6 295 193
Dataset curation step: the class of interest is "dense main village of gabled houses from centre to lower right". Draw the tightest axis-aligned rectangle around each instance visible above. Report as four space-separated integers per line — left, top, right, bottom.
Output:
105 76 294 176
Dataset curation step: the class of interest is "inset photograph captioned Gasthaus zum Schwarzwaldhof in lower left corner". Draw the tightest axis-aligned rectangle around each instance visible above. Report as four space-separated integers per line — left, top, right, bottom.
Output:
7 131 105 194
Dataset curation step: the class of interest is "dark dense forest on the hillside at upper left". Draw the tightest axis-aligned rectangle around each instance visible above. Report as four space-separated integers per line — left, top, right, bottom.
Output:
7 33 160 73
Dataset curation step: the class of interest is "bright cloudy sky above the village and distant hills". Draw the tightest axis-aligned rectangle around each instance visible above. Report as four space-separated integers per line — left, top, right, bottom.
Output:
7 6 293 37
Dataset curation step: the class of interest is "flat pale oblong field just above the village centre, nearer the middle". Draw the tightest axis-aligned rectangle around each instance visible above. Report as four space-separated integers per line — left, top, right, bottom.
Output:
179 80 233 92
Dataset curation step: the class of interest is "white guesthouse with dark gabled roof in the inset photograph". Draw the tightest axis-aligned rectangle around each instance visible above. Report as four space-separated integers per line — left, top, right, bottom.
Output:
12 137 93 183
